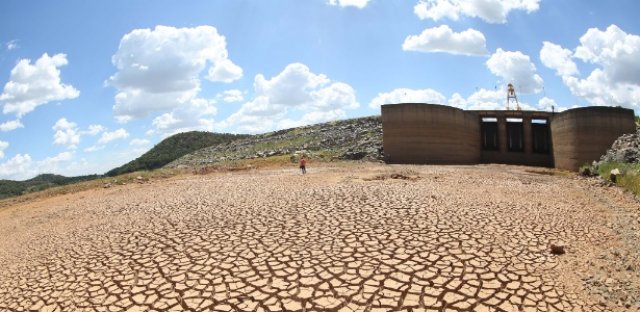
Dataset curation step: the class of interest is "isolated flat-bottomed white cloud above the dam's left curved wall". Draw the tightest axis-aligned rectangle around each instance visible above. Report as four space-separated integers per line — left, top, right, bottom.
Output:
402 25 488 55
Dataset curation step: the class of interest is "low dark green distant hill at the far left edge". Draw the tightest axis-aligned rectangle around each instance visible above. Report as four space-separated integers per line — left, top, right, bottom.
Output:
0 174 101 199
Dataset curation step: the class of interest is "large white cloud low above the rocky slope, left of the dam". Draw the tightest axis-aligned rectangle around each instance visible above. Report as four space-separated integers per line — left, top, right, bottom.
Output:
220 63 360 133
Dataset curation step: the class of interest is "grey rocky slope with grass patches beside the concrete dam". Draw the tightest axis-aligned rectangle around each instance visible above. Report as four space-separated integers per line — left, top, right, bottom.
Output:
166 116 382 168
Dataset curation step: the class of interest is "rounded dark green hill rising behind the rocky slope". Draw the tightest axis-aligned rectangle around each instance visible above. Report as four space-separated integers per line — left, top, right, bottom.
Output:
106 131 248 176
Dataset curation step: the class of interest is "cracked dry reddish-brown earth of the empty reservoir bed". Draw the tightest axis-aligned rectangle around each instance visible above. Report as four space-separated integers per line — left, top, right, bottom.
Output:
0 164 640 311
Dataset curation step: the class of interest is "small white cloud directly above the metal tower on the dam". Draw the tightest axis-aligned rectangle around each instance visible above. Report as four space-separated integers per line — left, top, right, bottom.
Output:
486 48 544 93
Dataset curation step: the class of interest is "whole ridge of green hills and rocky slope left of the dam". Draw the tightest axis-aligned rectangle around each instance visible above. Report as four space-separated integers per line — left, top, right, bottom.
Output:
0 116 382 199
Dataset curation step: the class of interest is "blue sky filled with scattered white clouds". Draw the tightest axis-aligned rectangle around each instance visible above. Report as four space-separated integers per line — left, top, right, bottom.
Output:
0 0 640 179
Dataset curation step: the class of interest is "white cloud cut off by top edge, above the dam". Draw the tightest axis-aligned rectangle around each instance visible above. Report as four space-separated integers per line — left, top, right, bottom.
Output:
413 0 540 24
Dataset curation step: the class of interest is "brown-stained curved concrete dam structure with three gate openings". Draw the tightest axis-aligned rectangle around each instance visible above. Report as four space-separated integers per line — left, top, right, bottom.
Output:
382 103 636 170
